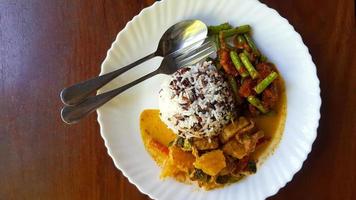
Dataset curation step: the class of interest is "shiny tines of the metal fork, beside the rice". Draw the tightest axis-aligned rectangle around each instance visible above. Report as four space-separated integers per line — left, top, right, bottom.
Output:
176 41 216 66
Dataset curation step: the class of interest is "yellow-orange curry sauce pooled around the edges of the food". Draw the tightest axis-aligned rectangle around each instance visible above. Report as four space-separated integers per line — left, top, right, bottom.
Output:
140 81 287 189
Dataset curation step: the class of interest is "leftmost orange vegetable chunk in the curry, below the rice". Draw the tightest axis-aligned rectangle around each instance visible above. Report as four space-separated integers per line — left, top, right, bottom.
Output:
169 146 195 172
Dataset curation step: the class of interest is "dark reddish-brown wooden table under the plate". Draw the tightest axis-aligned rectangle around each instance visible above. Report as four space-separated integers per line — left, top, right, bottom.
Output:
0 0 356 200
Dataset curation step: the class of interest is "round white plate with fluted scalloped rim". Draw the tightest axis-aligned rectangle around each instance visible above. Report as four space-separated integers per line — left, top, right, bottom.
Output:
98 0 321 200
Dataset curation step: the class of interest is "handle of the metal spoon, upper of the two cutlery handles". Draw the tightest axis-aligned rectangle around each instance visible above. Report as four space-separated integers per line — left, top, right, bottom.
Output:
60 52 156 106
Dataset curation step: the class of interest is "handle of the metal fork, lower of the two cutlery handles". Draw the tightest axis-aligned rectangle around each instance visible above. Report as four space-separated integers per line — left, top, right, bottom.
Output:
61 70 159 124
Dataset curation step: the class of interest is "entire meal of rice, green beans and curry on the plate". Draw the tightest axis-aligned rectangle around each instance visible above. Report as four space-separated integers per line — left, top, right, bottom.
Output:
140 23 286 190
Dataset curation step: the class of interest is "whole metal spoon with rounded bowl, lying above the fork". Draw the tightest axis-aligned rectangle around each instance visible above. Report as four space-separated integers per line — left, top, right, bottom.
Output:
60 20 208 105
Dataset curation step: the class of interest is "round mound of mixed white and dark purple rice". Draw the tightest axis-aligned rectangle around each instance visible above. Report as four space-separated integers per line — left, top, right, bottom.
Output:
159 62 235 138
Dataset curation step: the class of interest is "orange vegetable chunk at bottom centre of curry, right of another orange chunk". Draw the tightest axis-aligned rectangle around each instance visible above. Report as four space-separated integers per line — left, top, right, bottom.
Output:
194 150 226 176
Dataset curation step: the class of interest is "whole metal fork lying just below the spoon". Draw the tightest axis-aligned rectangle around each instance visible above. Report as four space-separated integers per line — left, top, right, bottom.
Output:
61 39 216 124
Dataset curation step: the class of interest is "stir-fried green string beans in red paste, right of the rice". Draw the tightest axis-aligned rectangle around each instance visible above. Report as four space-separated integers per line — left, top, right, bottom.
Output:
208 23 279 115
